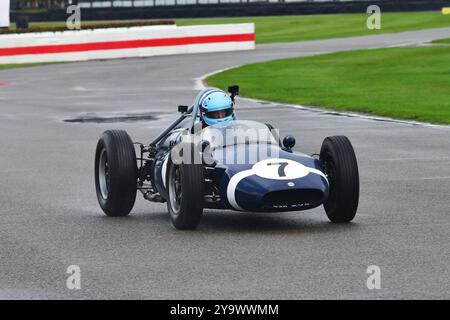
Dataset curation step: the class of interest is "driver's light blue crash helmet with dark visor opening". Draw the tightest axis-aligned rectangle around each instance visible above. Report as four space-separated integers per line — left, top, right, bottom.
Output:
199 89 235 126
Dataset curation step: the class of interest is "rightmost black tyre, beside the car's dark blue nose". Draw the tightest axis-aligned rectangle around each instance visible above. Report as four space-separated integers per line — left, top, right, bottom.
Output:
320 136 359 223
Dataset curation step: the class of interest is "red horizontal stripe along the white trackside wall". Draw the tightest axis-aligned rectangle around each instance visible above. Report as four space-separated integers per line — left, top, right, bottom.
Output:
0 33 255 56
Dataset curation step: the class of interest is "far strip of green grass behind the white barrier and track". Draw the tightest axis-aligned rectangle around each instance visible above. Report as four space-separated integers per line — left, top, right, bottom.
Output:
176 12 450 43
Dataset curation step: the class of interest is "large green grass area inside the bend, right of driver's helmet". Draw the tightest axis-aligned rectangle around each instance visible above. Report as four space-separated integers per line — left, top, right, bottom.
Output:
207 46 450 124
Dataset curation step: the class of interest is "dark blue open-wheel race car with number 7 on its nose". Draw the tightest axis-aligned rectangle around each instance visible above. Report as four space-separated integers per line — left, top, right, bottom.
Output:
95 86 359 229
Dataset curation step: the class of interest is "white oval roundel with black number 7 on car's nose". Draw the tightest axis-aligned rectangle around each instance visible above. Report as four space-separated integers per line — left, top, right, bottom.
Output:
252 158 311 180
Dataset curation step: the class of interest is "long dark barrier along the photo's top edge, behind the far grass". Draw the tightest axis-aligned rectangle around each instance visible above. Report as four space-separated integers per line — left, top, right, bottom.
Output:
10 0 450 22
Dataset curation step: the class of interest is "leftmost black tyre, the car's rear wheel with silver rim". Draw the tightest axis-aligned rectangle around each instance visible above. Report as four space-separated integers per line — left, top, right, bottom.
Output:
95 130 138 217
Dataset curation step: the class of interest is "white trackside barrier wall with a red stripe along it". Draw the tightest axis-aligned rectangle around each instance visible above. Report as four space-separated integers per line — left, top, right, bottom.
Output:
0 23 255 64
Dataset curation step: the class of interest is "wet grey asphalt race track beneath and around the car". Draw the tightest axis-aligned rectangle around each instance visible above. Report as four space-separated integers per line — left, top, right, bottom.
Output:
0 28 450 299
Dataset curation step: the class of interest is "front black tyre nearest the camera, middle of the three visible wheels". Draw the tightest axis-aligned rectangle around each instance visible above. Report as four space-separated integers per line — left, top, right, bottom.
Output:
166 144 205 230
